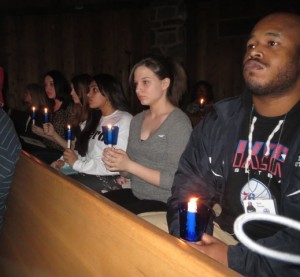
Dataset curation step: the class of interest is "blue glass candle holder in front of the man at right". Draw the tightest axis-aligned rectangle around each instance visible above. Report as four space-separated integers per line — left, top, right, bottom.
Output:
179 198 211 242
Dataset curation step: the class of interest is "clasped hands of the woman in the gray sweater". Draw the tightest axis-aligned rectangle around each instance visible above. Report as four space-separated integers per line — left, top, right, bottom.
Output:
102 147 130 171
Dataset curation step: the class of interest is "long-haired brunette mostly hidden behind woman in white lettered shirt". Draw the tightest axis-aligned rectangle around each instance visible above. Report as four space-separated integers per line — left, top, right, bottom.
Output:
42 74 92 149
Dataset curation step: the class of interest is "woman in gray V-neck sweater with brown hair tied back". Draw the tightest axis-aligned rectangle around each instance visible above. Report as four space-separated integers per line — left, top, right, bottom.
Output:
103 53 192 214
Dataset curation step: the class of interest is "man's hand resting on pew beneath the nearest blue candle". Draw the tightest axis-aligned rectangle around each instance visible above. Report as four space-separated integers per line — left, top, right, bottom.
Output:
190 233 228 266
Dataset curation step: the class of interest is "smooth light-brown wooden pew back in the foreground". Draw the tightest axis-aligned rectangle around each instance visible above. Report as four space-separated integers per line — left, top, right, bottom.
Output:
0 152 239 277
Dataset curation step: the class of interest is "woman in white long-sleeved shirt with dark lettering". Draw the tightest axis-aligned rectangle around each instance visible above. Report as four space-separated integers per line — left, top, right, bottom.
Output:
56 74 132 193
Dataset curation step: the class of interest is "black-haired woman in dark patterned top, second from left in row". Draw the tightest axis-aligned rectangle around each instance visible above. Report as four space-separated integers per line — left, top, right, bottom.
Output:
32 70 73 163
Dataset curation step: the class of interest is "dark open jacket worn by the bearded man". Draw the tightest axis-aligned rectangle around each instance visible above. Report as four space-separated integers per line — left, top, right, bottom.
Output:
167 93 300 276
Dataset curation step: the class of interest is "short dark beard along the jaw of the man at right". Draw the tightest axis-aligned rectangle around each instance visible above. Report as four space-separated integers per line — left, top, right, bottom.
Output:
245 55 300 96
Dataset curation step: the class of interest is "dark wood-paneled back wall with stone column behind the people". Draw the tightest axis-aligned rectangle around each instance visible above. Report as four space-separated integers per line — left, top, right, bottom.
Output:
0 0 300 112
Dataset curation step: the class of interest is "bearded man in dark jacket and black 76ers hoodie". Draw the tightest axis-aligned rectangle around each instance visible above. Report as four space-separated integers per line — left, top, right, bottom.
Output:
167 13 300 276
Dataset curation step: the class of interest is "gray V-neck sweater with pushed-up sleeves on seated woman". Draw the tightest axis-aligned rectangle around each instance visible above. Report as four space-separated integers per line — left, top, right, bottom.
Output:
127 108 192 203
